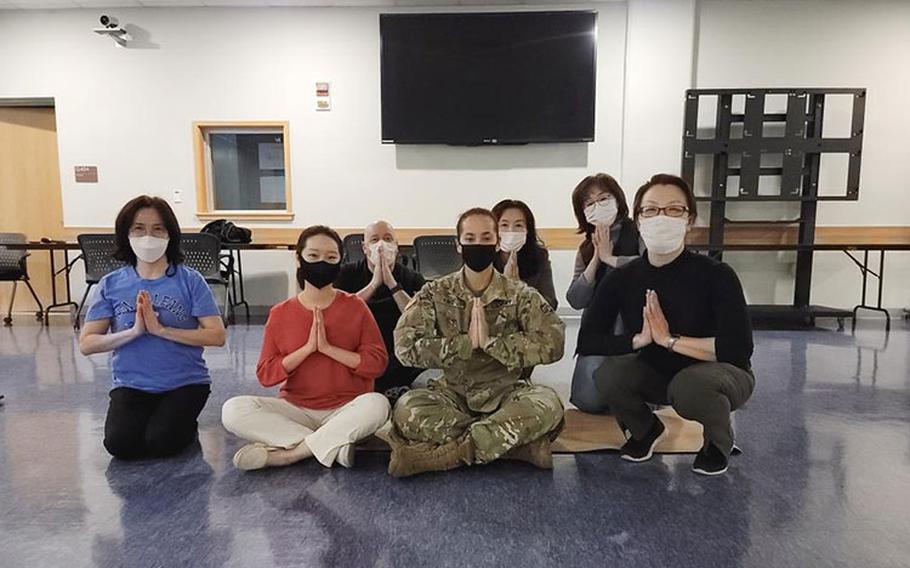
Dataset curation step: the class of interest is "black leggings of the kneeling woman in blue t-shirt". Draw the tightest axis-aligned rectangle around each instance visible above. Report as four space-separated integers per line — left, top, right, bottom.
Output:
104 385 211 459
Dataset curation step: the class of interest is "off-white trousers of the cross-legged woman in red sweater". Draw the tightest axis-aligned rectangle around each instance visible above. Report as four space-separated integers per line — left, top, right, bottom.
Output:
221 392 390 467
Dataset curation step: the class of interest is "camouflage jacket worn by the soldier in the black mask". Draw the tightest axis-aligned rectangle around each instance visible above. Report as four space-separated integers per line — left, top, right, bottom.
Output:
395 269 565 412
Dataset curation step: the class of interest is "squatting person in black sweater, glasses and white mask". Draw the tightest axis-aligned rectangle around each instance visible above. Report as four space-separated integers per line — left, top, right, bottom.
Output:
578 174 755 475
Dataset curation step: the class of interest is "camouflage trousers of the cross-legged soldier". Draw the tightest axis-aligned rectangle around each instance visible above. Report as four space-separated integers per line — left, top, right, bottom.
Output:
392 383 564 463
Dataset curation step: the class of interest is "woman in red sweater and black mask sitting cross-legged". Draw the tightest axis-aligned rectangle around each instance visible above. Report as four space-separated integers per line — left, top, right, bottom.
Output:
221 226 389 470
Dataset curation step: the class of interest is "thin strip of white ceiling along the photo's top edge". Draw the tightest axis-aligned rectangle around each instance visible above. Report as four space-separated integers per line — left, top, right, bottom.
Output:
0 0 616 10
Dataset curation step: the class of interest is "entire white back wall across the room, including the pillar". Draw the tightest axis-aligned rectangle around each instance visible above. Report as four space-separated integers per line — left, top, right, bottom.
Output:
0 0 910 307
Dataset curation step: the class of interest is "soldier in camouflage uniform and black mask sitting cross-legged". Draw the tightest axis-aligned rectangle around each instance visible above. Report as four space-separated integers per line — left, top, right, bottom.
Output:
387 209 565 477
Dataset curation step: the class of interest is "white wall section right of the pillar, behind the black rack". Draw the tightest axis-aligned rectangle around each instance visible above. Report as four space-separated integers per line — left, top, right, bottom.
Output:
696 0 910 307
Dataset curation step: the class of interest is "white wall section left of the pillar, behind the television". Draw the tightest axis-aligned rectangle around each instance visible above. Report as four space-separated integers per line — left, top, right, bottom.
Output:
0 3 625 231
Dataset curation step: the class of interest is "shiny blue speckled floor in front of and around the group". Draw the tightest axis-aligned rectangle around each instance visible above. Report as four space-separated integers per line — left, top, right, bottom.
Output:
0 317 910 568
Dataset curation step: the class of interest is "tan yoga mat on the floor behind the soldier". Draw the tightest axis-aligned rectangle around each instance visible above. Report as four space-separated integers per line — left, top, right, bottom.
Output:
357 406 703 454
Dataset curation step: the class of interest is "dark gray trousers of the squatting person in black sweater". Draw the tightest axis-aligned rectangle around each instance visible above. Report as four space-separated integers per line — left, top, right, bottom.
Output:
594 353 755 456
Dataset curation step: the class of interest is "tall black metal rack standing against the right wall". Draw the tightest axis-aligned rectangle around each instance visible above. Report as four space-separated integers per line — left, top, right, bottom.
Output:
682 88 866 324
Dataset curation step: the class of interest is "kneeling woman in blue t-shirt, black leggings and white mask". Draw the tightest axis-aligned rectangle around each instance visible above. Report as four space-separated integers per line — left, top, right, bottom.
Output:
79 195 224 459
